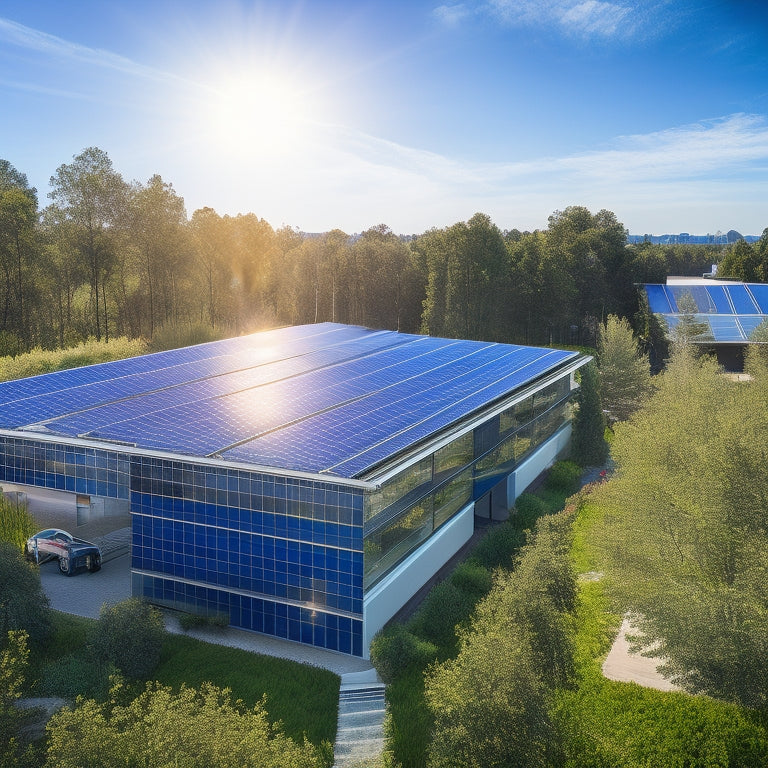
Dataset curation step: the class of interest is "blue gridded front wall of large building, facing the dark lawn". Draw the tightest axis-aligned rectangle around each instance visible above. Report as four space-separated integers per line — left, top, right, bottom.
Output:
131 457 363 655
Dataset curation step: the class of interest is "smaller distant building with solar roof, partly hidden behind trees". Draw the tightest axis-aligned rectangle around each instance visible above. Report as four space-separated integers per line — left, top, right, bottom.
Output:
643 277 768 371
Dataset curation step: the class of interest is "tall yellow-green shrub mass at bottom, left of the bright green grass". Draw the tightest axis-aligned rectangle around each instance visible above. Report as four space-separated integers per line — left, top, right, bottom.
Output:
425 516 575 768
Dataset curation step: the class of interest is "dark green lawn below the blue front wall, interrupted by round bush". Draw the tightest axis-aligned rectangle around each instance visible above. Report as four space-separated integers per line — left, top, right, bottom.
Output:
29 611 340 745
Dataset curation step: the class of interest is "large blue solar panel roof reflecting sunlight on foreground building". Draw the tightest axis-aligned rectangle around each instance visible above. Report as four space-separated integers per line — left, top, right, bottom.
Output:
0 323 578 478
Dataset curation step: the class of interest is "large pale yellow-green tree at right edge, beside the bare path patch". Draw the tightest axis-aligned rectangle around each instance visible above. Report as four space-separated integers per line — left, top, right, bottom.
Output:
596 346 768 708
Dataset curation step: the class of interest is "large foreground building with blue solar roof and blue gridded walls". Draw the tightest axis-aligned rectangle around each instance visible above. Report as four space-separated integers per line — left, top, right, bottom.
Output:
0 323 588 656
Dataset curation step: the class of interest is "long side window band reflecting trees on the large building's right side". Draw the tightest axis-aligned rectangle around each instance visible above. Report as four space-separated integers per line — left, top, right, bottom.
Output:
364 376 571 589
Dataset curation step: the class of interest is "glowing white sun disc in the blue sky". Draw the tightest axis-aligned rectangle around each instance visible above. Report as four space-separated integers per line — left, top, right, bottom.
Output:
204 73 311 156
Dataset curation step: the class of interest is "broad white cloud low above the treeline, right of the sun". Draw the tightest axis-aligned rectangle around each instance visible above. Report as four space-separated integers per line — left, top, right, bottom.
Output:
236 114 768 234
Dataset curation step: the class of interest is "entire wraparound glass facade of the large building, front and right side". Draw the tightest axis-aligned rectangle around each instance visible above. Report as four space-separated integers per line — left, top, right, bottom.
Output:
0 368 570 656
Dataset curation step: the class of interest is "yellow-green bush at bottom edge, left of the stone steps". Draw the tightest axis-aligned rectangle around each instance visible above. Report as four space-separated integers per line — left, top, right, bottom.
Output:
46 683 323 768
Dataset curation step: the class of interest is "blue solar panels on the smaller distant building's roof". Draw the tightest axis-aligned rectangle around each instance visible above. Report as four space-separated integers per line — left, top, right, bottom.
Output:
643 282 768 344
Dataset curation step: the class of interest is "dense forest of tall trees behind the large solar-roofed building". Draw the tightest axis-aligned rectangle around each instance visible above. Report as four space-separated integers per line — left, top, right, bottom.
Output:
0 147 752 356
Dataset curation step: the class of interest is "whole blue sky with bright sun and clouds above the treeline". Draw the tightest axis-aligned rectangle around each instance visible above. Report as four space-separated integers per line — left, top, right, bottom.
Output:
0 0 768 235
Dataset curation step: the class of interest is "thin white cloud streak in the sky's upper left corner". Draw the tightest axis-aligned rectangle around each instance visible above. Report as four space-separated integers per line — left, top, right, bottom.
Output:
0 18 178 81
